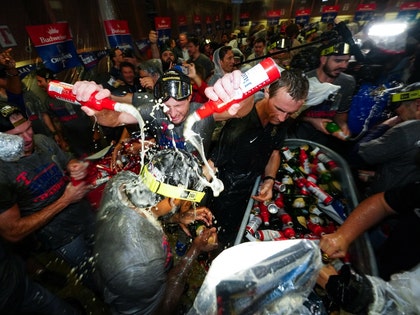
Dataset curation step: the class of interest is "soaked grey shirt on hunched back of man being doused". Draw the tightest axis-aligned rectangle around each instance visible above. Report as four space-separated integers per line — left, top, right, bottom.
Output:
94 171 172 314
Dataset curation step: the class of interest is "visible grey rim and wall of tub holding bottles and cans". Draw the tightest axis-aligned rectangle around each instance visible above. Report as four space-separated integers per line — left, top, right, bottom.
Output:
235 139 378 276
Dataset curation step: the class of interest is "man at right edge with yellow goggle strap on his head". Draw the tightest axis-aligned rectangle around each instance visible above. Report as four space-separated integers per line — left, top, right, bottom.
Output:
358 82 420 194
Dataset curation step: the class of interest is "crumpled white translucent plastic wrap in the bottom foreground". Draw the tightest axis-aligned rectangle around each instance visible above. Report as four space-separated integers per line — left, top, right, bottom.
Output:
188 240 322 315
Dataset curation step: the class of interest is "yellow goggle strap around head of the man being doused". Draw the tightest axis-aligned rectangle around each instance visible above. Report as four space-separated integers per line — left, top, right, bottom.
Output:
140 166 206 202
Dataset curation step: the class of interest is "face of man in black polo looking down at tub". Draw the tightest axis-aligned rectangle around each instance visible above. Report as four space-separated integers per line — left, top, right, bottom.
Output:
268 87 305 125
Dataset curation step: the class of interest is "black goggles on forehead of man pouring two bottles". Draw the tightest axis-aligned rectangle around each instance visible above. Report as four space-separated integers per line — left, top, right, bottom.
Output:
153 71 192 102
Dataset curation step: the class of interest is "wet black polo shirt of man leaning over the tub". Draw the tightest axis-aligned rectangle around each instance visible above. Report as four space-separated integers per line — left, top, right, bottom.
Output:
209 107 287 245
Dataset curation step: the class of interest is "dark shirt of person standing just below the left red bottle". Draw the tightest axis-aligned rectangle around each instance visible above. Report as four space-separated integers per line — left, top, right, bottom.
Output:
42 97 95 157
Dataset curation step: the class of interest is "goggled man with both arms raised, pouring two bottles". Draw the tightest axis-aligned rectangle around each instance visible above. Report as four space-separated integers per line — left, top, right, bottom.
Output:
73 70 253 157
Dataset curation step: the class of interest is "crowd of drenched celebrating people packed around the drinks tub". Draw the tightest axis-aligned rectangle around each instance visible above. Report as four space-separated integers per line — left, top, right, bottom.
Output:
0 16 420 314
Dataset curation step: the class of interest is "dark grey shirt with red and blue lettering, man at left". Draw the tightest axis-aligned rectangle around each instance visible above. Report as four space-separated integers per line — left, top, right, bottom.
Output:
0 135 91 249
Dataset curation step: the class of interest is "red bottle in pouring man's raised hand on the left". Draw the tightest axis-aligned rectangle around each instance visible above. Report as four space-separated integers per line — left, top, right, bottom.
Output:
47 80 127 112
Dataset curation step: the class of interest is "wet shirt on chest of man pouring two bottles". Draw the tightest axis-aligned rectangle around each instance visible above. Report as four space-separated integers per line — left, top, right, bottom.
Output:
133 97 215 156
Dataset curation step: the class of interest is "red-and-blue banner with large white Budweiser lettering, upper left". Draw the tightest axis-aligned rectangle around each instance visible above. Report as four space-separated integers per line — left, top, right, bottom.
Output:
26 22 81 73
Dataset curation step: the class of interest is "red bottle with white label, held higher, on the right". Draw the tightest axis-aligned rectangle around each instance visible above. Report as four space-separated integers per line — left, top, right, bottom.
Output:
194 58 280 121
